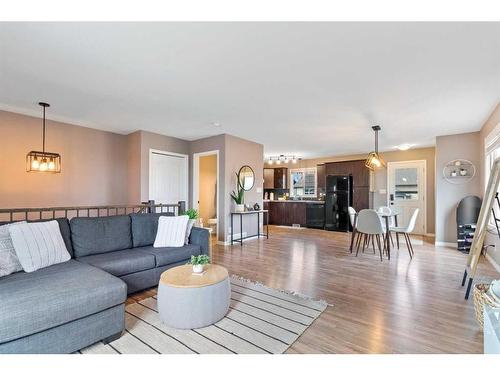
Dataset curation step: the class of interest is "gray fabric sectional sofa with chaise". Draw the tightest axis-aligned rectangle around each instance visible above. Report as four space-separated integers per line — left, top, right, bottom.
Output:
0 214 209 353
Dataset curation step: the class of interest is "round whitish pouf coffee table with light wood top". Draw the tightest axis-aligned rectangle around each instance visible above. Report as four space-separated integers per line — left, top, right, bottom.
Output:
157 264 231 329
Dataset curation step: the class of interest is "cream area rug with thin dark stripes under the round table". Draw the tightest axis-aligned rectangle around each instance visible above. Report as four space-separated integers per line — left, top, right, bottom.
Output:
80 276 327 354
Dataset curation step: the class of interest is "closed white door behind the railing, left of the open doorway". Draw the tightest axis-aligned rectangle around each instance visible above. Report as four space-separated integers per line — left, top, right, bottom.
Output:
149 150 188 209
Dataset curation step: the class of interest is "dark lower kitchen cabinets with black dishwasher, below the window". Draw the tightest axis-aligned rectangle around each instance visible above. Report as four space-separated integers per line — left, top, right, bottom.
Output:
264 200 325 229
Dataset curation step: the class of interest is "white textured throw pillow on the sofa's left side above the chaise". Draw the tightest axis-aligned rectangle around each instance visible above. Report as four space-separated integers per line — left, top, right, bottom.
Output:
9 220 71 272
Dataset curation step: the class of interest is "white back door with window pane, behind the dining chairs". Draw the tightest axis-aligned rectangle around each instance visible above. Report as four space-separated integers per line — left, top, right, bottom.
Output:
387 160 426 234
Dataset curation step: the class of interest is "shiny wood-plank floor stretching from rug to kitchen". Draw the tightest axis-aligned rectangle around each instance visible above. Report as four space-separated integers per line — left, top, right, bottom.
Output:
128 226 498 353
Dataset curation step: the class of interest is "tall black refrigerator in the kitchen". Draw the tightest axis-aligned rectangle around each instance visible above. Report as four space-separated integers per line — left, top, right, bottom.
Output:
325 175 352 232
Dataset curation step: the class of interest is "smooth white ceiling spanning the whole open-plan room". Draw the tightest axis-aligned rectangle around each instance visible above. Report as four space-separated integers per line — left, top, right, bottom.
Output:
0 23 500 158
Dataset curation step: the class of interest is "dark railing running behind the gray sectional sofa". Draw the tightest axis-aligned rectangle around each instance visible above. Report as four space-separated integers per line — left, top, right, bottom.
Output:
0 200 186 222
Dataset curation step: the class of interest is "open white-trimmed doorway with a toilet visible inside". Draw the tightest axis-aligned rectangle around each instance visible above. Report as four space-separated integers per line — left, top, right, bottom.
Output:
193 150 219 239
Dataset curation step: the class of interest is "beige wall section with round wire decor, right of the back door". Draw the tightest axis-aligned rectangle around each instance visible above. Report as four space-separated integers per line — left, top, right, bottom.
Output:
436 132 481 244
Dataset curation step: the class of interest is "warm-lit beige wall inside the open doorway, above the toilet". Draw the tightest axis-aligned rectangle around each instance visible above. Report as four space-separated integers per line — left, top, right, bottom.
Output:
198 154 217 224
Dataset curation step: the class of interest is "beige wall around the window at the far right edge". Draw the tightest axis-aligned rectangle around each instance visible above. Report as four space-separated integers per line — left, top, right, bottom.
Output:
479 103 500 271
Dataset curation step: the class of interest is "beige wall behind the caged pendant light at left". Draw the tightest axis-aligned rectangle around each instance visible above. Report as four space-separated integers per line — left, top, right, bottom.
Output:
0 111 129 208
